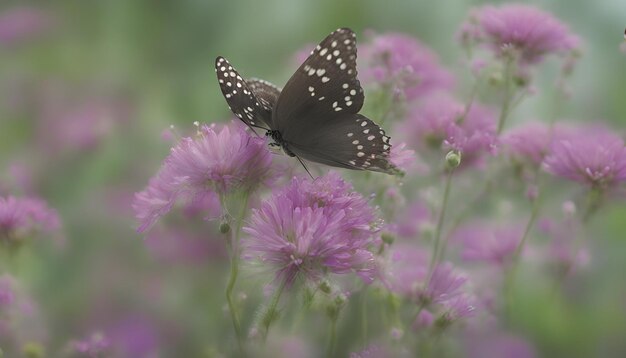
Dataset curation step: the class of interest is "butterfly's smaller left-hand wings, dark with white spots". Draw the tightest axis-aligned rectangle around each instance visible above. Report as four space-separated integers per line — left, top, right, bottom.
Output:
215 57 280 130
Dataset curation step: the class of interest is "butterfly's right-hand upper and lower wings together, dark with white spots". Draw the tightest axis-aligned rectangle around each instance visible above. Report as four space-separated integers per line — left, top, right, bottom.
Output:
272 28 395 173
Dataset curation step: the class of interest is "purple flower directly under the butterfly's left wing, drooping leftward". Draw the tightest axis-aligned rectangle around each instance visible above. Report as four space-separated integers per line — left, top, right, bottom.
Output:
133 126 275 232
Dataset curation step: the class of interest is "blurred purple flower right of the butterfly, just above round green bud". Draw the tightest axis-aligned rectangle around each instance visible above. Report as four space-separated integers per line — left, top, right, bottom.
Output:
399 95 497 166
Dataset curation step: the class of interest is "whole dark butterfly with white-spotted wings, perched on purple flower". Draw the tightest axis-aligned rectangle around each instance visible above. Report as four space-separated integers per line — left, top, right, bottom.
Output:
215 28 399 174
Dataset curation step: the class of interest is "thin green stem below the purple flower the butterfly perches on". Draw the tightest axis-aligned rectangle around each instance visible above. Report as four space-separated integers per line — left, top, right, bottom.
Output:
222 193 249 353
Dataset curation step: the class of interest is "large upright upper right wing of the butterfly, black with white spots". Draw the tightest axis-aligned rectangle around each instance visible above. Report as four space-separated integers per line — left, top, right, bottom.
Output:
272 28 364 142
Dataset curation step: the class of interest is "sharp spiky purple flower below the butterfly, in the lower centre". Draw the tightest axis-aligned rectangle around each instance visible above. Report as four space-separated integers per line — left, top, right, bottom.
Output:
243 172 376 285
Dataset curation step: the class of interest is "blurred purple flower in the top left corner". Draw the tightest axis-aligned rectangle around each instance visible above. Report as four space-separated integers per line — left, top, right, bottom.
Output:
0 7 53 45
